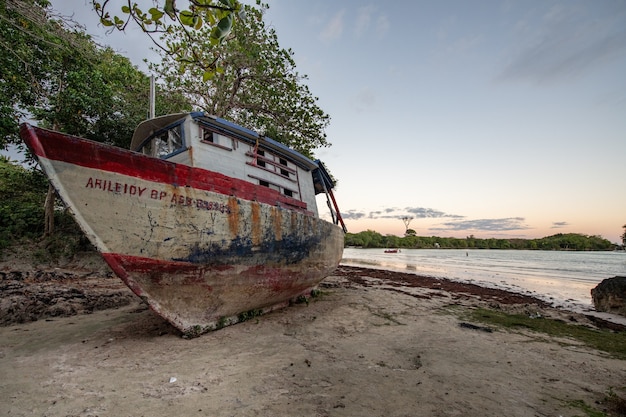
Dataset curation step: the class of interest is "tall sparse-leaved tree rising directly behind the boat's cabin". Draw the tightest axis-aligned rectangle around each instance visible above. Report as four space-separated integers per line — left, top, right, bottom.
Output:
152 5 330 156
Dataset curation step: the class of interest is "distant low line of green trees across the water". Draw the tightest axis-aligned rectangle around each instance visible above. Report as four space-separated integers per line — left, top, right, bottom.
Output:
345 230 617 251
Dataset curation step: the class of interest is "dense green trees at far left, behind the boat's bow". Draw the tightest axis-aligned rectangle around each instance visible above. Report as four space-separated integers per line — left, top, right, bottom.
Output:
0 0 191 235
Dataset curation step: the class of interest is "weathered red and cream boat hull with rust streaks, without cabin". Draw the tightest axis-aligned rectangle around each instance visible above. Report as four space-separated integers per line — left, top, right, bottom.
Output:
22 126 343 336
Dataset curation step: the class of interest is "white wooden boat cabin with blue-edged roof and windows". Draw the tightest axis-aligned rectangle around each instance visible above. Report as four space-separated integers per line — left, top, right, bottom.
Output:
131 112 335 218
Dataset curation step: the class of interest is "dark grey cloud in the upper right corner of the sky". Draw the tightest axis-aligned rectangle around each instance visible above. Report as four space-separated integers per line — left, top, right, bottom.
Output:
497 7 626 83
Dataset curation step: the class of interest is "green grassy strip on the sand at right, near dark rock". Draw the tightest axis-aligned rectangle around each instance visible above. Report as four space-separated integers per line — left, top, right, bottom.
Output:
469 308 626 359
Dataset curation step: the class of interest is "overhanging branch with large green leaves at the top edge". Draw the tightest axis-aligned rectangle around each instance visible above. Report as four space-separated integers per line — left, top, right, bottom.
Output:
92 0 243 79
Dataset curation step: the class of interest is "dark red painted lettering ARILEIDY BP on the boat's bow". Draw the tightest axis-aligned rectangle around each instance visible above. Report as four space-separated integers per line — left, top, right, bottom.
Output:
85 177 230 214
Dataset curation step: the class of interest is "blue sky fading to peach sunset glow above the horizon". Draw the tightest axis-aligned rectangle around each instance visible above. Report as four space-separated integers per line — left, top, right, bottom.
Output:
42 0 626 243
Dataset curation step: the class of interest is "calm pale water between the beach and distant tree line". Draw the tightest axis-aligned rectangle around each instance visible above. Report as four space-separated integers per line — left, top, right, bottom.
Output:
341 248 626 311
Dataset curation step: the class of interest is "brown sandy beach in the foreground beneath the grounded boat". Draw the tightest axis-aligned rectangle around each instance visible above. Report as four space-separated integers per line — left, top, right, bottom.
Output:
0 258 626 417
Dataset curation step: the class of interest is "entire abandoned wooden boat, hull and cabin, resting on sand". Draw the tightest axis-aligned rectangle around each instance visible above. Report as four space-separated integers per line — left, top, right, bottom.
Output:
20 112 345 337
